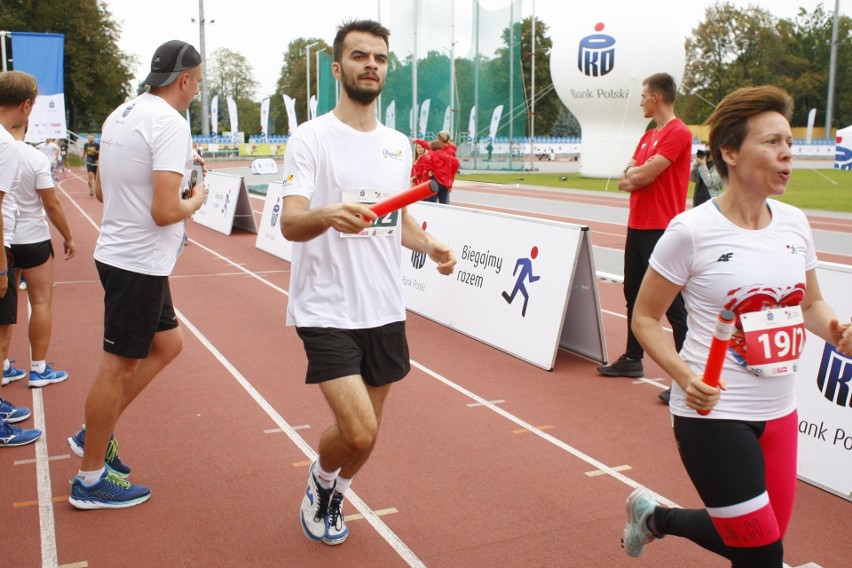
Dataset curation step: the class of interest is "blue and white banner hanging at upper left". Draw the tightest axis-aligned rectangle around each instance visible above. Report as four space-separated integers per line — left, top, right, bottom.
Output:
12 32 68 142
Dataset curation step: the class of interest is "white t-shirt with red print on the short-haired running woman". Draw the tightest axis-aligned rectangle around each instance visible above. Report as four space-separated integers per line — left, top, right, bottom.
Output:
650 199 817 421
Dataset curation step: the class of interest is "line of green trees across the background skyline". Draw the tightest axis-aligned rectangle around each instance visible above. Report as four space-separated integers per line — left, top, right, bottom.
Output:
0 0 852 136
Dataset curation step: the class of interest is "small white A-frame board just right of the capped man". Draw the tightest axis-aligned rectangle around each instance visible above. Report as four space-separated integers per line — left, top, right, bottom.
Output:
192 172 257 235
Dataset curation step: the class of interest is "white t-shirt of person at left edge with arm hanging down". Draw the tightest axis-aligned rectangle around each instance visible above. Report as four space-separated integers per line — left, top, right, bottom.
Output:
12 141 53 245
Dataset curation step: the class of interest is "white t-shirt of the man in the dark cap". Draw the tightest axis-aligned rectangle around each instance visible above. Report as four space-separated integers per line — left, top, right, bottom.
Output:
95 93 192 276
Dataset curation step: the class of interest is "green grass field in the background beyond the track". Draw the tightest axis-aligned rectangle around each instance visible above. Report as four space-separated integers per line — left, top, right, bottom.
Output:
457 169 852 213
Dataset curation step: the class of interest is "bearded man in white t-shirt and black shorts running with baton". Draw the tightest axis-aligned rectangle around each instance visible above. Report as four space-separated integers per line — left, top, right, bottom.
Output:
281 20 456 544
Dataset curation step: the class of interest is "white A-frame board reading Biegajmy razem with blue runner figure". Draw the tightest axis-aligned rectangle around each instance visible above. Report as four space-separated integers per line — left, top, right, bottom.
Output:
402 202 606 370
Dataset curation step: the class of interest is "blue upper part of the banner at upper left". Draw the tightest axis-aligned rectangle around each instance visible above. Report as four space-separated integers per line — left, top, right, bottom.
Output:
12 32 65 96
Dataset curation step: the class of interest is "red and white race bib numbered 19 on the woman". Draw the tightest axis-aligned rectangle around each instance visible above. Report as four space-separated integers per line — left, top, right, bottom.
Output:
740 306 805 377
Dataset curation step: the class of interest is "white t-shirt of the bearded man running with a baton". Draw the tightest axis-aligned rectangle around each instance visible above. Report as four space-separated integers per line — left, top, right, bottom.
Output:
284 112 411 329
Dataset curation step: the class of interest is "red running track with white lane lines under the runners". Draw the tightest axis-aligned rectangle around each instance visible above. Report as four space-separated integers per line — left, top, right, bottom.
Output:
0 168 850 568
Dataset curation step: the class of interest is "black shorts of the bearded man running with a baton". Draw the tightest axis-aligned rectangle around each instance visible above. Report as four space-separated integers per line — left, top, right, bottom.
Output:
296 321 411 387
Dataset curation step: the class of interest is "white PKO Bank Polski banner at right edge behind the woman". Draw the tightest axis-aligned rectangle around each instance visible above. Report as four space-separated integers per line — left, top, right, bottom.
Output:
796 263 852 501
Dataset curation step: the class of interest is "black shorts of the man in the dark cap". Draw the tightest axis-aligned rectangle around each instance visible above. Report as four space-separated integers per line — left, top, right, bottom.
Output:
95 260 178 359
